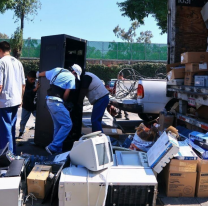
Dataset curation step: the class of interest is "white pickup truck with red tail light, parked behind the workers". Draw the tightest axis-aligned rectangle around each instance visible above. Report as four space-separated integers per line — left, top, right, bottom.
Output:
111 79 176 121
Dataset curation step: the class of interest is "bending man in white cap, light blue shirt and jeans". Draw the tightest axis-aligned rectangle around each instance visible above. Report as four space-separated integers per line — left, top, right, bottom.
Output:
38 64 82 155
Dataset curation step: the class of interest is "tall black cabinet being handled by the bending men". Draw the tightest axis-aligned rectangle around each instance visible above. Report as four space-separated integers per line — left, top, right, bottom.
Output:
34 34 87 150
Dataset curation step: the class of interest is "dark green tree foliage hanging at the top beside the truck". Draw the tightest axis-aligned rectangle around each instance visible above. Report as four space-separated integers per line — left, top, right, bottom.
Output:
117 0 168 34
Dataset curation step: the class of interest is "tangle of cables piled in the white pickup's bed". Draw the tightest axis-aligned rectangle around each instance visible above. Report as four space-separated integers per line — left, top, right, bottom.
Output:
112 68 166 99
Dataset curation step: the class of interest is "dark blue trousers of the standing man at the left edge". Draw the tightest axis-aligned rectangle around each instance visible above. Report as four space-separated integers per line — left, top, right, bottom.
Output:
0 106 18 154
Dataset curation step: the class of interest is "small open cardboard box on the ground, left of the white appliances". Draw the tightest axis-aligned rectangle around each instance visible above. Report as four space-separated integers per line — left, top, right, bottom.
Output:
27 165 52 199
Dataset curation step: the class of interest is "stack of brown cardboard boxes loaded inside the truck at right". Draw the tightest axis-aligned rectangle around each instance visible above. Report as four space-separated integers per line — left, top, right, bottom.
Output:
181 52 208 86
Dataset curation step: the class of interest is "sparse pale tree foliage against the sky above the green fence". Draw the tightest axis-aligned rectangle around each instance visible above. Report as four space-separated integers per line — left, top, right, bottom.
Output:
113 21 153 43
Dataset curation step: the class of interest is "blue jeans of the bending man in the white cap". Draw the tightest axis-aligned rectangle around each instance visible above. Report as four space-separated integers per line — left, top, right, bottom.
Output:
46 100 72 153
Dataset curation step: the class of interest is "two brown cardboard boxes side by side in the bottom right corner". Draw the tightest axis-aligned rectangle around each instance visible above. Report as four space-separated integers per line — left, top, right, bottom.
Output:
164 158 208 197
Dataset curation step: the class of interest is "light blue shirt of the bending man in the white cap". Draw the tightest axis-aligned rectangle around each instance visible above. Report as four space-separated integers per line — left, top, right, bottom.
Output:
45 67 76 101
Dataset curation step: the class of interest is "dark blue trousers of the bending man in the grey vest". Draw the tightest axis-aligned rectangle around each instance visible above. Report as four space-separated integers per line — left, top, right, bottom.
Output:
91 95 109 132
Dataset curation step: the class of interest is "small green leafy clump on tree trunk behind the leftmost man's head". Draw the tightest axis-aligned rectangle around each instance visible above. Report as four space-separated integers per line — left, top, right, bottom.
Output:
10 27 23 59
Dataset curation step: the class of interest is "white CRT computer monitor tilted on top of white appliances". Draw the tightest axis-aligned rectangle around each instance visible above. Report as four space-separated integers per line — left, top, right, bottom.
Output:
69 132 113 171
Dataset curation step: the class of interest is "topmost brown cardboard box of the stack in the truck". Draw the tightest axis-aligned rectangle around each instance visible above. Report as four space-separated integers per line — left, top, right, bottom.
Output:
181 52 208 64
